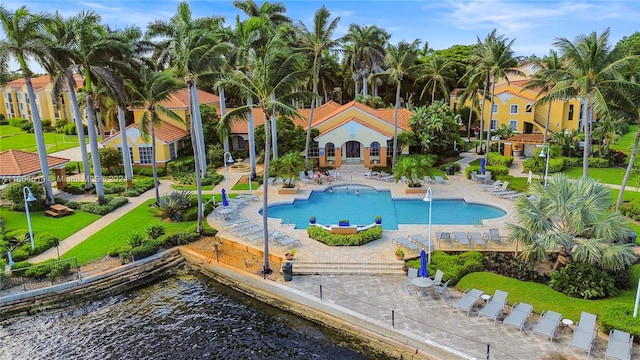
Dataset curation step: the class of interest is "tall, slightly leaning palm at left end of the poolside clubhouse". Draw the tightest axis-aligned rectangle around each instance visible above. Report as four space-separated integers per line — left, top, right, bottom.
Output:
296 6 340 169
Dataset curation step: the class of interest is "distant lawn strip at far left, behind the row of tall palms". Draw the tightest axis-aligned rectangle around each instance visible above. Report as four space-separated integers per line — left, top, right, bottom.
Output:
0 125 91 153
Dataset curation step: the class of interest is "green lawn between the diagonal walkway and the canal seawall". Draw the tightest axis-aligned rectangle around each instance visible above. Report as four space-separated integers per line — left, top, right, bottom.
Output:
61 195 216 266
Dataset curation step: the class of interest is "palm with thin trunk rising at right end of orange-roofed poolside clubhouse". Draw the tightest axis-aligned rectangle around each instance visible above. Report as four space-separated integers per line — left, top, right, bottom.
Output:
372 39 420 169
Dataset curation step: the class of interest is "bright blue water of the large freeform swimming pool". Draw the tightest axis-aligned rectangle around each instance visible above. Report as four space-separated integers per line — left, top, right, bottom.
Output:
268 186 505 230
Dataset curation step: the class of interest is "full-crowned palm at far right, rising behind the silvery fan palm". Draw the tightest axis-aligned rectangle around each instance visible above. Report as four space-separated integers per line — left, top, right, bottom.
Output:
548 29 635 178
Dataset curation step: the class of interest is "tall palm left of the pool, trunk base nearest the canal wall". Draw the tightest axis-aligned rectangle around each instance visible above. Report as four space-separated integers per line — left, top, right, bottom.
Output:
216 33 312 274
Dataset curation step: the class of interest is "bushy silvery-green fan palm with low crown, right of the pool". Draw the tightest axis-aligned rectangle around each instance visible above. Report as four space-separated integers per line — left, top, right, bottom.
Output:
507 174 636 270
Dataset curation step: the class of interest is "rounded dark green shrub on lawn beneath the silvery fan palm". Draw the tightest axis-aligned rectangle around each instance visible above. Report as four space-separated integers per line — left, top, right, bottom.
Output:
549 263 616 299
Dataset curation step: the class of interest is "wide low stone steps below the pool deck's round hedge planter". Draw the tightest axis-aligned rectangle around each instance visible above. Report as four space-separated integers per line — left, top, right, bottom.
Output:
293 260 405 275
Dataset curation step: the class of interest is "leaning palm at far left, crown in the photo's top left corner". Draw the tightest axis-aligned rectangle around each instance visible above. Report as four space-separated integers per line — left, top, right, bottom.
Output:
0 5 55 204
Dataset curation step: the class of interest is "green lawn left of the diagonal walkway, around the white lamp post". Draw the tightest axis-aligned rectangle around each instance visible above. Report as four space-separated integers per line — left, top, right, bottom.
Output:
0 207 101 240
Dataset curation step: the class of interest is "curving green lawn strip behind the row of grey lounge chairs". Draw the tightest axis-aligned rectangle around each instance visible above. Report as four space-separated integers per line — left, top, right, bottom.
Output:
457 265 640 322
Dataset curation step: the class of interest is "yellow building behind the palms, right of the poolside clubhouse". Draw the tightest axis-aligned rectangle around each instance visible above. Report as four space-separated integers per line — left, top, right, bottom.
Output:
450 64 585 155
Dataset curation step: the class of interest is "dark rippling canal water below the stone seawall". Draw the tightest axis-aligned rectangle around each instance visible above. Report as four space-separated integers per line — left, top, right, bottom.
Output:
0 274 389 360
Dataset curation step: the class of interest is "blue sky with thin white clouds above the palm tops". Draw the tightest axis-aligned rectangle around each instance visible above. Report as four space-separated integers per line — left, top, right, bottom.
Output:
2 0 640 56
